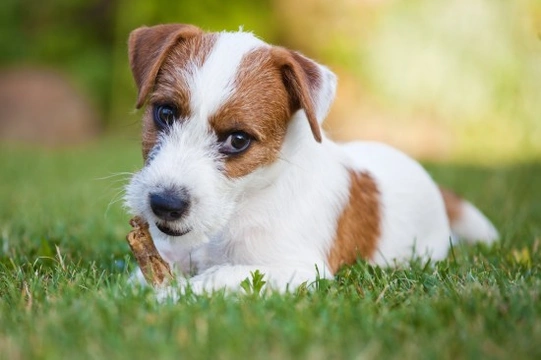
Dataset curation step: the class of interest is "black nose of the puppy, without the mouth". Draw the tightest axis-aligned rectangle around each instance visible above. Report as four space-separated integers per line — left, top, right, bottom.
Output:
149 190 190 221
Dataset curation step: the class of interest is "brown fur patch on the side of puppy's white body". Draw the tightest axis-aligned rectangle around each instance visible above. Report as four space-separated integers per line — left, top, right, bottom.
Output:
327 170 381 273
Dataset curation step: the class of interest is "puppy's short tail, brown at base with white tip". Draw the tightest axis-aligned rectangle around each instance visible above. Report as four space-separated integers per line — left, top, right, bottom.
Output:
440 187 499 244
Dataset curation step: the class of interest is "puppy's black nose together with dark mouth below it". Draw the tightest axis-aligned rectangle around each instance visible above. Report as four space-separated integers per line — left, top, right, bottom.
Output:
149 189 190 236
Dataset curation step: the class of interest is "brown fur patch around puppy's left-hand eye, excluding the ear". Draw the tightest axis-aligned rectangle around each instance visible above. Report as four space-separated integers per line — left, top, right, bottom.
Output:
135 34 216 160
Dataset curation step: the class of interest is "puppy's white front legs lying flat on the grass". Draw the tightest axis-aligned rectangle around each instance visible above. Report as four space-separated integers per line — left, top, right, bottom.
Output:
157 264 326 300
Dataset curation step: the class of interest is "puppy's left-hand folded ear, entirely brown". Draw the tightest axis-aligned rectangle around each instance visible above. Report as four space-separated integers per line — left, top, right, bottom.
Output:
128 24 202 109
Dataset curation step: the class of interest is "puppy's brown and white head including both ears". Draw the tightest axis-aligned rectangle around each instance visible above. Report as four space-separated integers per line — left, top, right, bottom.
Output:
126 24 336 246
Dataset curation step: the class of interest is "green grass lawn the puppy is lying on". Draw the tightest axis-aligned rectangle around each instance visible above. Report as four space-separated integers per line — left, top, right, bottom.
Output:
0 139 541 359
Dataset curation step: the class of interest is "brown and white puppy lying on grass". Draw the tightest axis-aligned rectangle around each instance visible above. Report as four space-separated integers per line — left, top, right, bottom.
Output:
125 24 498 293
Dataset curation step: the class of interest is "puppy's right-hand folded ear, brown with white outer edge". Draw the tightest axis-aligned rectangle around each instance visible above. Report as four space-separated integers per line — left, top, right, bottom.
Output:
272 47 336 142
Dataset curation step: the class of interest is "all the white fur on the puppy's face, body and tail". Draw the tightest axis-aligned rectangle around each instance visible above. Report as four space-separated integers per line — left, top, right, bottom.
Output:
126 24 498 293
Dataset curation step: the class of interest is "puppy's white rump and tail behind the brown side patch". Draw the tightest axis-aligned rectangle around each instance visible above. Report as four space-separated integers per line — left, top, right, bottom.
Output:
343 142 498 264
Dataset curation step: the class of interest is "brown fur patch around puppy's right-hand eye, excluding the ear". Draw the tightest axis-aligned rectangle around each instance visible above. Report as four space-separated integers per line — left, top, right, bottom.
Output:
209 48 291 177
